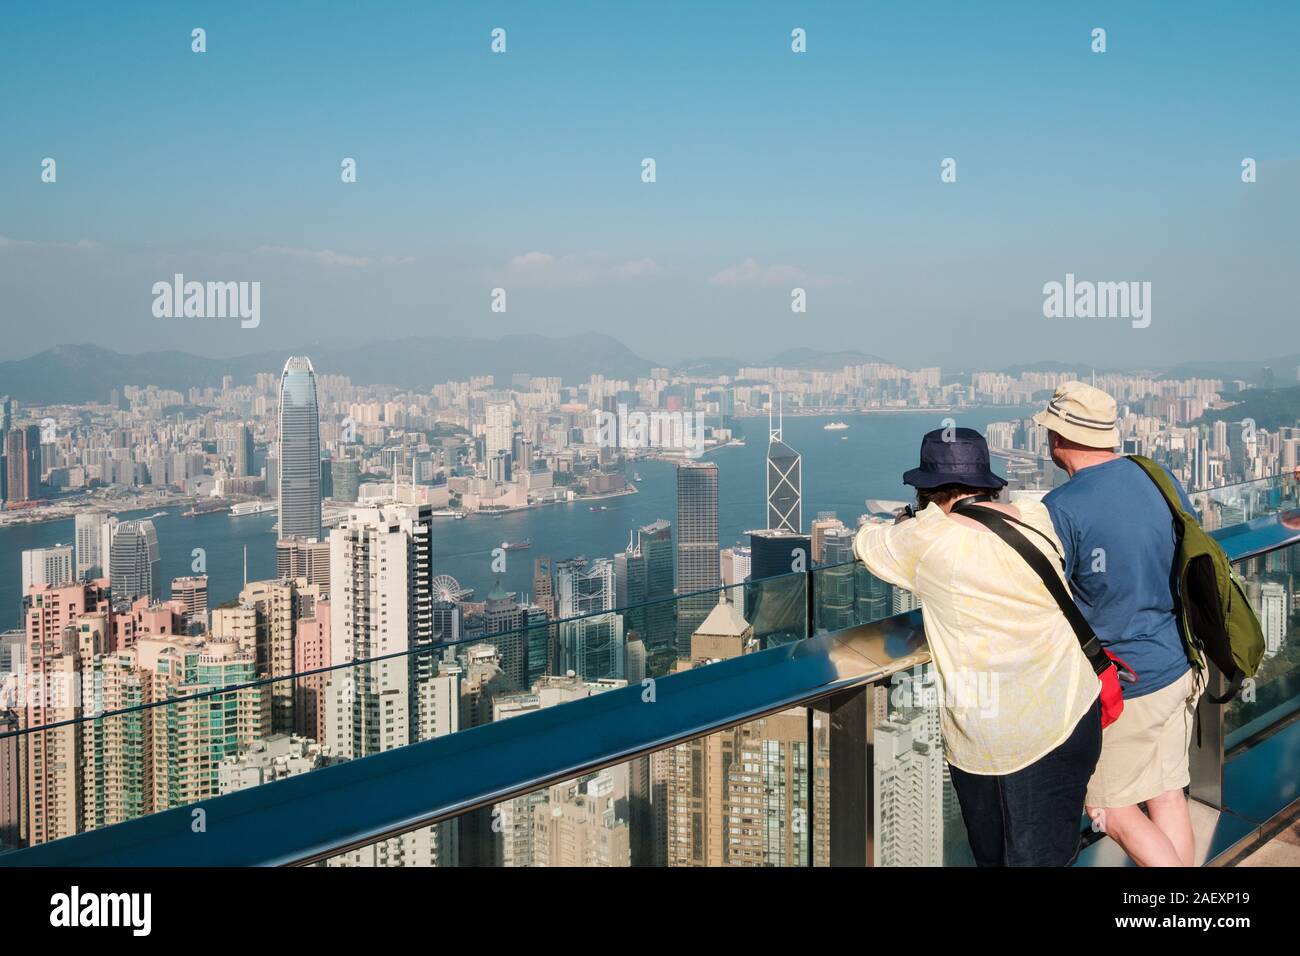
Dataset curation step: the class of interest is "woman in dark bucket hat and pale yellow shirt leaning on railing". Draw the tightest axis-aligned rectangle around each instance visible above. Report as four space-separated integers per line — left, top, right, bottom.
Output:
854 428 1101 866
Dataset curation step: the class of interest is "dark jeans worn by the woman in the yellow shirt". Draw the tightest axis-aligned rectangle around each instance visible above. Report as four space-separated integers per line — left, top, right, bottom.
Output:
950 698 1101 866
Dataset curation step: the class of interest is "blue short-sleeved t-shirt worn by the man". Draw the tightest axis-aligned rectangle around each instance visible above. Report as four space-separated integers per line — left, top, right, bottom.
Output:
1043 458 1196 698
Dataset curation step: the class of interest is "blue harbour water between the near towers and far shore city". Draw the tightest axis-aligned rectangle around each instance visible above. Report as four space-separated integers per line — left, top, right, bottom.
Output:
0 408 1024 630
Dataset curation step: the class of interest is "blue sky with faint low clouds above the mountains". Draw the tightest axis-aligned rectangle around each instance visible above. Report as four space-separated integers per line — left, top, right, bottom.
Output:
0 1 1300 367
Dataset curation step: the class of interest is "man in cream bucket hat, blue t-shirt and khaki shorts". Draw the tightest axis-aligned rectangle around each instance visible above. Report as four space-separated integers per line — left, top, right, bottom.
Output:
1034 381 1203 866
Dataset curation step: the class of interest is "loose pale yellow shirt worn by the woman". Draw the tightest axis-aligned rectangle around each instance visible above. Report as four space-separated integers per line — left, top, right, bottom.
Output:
853 501 1101 774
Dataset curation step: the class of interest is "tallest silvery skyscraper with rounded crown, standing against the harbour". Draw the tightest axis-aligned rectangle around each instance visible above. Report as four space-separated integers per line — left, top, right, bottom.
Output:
280 355 321 540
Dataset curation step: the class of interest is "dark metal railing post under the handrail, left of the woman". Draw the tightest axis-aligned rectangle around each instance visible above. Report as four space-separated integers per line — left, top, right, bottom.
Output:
815 684 875 866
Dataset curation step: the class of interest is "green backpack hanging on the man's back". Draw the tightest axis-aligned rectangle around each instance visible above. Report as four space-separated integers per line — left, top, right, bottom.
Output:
1130 455 1264 704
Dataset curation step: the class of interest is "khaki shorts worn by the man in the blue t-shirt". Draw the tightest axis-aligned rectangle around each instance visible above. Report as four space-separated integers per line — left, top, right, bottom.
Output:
1084 667 1203 808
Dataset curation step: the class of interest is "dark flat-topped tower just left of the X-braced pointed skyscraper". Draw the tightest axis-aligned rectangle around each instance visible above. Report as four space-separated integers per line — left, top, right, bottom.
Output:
677 462 722 657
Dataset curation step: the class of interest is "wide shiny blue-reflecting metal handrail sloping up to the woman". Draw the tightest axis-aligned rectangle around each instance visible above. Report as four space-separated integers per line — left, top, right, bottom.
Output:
0 611 930 866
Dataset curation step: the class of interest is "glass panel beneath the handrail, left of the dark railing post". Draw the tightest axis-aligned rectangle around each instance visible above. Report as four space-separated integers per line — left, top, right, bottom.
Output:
319 708 829 866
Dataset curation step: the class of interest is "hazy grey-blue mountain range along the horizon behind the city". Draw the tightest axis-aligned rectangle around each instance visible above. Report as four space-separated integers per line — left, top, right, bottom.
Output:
0 333 1300 403
